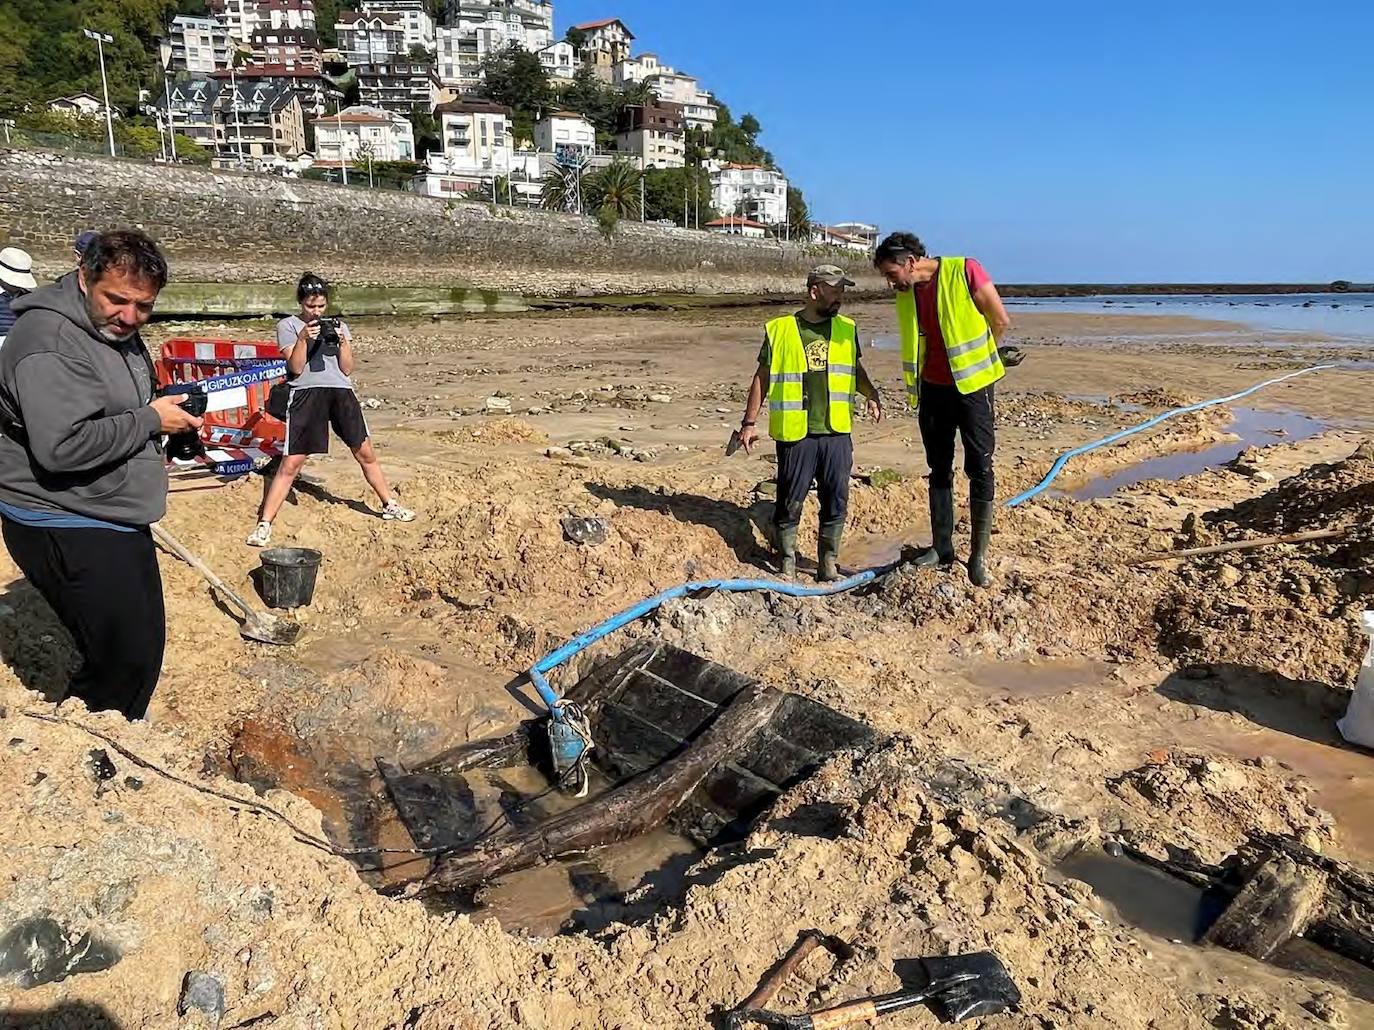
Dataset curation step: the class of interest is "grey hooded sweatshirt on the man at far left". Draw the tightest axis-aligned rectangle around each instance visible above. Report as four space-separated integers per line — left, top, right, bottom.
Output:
0 276 168 526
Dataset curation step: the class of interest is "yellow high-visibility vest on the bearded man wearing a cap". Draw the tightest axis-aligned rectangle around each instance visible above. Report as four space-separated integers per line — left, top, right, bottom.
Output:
768 314 859 444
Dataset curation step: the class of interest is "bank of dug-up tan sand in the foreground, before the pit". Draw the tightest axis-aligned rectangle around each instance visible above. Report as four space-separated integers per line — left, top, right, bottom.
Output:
8 707 1352 1030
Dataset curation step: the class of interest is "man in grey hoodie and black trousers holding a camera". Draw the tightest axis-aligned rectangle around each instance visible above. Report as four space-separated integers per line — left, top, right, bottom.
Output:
0 231 201 718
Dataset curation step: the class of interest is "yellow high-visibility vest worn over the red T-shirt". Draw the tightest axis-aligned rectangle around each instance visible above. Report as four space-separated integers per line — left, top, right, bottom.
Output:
897 257 1006 408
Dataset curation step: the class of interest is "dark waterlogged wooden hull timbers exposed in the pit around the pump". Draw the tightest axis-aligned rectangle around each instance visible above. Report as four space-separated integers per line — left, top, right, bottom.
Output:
378 640 878 891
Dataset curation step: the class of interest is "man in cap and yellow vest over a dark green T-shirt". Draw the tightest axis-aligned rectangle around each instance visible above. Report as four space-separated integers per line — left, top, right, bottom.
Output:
739 265 882 582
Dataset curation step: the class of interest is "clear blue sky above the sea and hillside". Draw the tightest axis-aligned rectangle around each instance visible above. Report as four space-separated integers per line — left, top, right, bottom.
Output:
554 0 1374 282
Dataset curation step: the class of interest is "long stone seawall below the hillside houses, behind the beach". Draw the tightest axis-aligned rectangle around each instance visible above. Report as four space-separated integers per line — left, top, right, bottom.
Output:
0 150 867 297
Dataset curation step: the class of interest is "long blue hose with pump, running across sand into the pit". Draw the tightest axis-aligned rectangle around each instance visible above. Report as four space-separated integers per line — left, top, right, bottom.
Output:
528 364 1336 794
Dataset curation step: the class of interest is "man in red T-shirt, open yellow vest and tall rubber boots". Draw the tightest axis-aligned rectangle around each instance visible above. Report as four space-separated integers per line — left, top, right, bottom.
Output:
872 232 1020 586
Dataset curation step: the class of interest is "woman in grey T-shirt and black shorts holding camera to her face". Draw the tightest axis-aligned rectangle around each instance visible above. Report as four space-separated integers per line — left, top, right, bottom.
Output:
247 272 415 547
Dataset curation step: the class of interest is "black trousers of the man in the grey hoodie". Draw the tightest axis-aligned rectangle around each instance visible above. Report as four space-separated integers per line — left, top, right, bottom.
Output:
4 519 166 718
